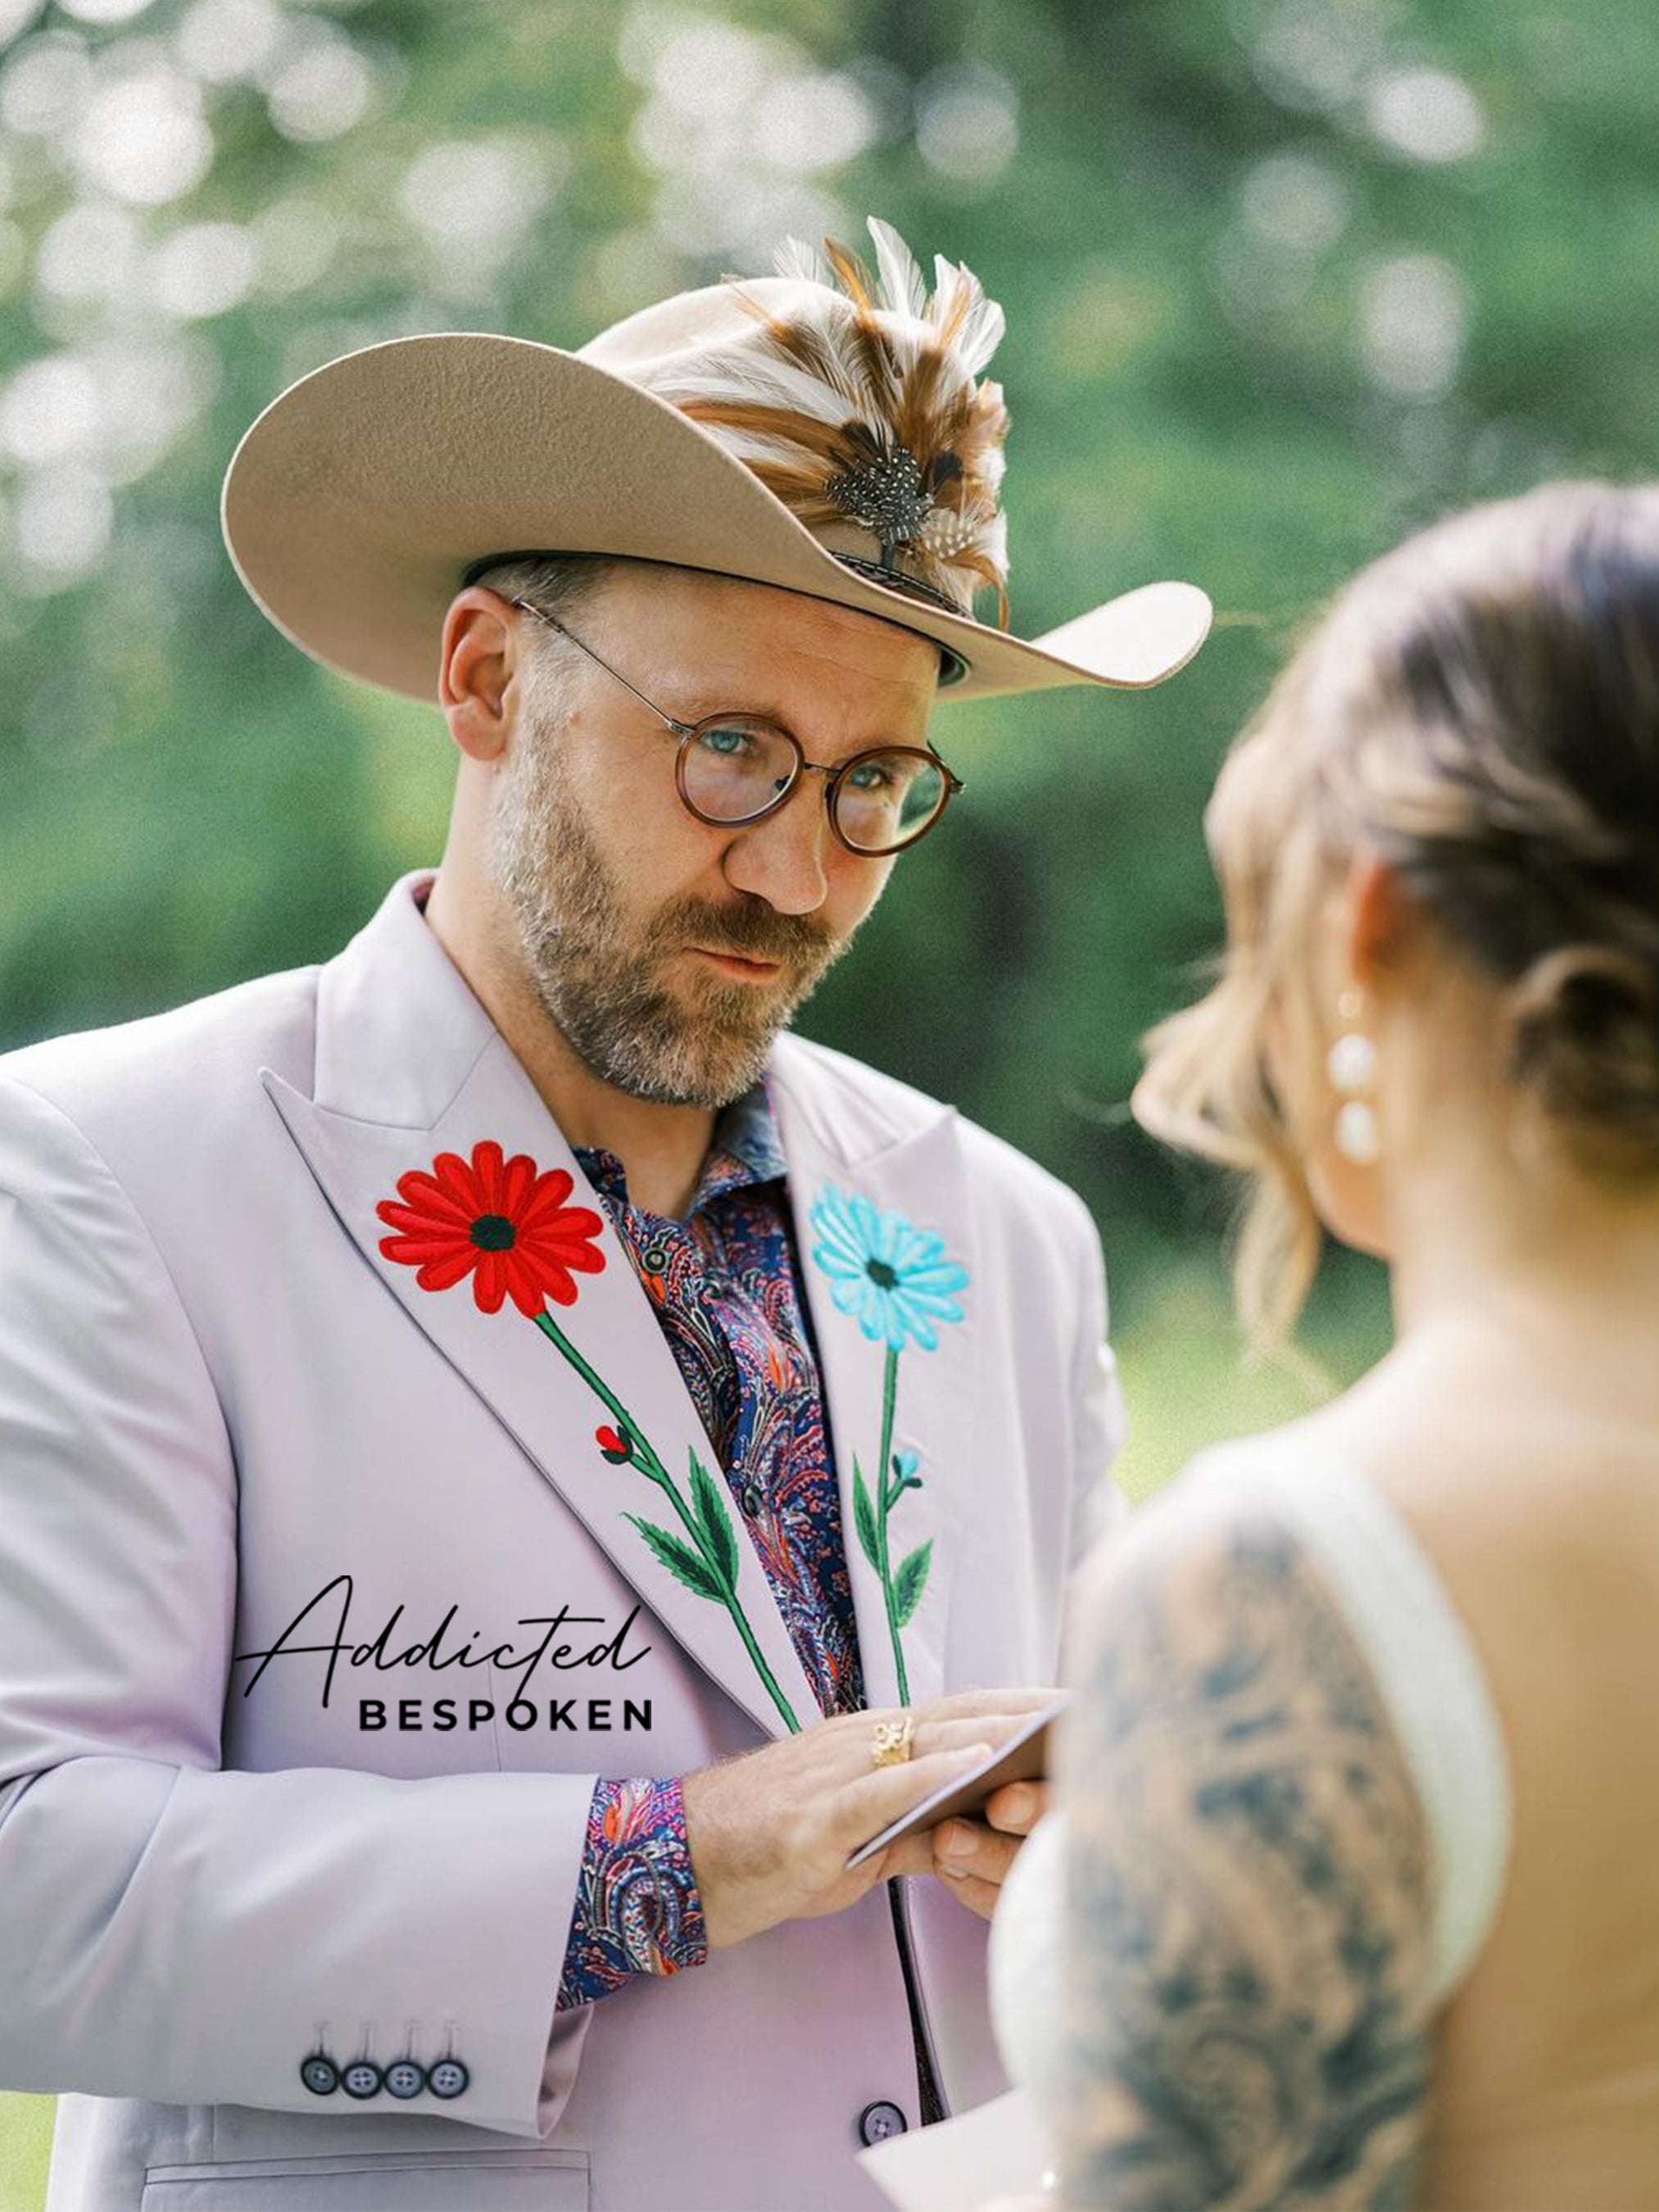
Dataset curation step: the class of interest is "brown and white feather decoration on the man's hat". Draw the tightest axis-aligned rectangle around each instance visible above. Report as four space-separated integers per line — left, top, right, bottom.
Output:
653 217 1009 628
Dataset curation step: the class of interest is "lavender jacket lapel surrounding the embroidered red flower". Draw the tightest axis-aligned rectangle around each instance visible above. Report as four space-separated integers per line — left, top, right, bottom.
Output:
263 878 818 1737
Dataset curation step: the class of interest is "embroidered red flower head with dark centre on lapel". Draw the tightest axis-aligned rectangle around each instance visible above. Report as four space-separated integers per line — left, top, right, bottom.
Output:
374 1137 604 1321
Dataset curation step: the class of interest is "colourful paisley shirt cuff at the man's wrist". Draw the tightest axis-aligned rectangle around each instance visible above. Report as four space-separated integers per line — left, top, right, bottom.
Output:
555 1776 708 2013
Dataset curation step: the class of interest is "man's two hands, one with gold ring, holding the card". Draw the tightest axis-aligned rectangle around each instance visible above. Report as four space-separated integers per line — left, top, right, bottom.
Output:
682 1688 1055 1949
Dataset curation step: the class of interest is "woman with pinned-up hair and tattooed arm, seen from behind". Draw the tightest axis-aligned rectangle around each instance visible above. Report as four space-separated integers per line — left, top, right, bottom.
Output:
871 484 1659 2212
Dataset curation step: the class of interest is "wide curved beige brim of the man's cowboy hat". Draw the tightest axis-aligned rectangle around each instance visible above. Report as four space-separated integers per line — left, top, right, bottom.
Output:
219 332 1210 701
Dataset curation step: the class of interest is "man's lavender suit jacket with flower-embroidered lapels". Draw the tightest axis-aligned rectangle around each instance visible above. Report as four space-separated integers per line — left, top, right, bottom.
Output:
0 876 1122 2212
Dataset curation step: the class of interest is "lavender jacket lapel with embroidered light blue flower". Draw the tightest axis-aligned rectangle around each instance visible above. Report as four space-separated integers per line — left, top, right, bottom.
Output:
772 1037 982 1707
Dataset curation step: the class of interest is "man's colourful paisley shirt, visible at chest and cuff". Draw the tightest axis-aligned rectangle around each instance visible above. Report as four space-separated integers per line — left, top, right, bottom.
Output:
557 1077 865 2010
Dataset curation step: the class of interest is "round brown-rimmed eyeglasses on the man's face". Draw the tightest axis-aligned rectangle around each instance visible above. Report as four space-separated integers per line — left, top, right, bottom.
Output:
511 600 964 860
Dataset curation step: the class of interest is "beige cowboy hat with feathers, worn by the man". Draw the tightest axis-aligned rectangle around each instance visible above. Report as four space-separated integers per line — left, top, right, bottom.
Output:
221 219 1210 701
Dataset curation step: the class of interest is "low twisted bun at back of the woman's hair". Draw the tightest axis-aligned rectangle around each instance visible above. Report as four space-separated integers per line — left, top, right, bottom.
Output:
1504 945 1659 1175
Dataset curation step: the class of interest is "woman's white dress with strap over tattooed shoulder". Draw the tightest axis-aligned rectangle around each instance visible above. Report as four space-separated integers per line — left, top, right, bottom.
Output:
860 1438 1511 2212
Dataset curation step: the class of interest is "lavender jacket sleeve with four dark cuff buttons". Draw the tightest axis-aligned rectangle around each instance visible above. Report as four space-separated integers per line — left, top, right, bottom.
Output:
0 1077 595 2137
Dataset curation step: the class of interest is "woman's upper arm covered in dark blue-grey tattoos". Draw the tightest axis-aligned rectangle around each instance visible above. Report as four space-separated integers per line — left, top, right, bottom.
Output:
1051 1511 1431 2212
